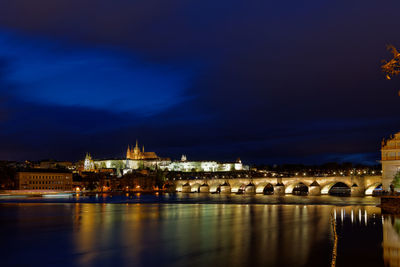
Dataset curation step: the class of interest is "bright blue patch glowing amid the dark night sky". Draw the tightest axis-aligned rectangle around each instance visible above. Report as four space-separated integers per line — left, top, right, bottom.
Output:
0 32 194 115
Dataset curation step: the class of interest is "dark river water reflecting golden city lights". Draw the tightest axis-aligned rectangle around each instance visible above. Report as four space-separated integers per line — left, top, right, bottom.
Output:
0 194 400 267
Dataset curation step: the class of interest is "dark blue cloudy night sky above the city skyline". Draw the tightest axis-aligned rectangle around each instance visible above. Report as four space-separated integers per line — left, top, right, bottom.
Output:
0 0 400 164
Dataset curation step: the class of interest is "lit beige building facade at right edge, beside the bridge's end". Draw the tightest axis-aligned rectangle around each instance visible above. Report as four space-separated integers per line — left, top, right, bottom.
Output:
381 132 400 191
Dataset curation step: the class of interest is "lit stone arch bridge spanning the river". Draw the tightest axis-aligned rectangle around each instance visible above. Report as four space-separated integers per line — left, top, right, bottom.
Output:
166 176 382 196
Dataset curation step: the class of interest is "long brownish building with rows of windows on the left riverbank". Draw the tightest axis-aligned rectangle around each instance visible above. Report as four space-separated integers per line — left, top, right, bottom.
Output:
17 169 72 191
